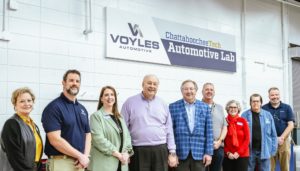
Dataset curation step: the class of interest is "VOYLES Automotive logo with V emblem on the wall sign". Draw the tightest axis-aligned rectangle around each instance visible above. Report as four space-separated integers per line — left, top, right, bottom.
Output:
110 23 159 50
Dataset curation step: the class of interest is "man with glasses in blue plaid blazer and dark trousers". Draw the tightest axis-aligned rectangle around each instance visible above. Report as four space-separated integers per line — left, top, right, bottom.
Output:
169 80 213 171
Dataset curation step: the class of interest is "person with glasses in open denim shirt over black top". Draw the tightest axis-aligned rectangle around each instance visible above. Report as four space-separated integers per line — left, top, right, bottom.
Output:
242 94 277 171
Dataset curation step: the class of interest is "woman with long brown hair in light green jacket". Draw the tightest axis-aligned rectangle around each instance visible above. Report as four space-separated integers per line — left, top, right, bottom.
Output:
89 86 133 171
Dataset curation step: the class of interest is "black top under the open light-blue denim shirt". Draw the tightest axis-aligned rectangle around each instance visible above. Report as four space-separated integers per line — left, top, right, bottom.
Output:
252 112 261 151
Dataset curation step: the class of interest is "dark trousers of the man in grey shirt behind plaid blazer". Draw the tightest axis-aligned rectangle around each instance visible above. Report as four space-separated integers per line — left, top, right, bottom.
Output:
206 147 224 171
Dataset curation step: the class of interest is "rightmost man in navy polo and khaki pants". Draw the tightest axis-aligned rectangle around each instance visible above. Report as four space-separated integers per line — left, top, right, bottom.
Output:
263 87 295 171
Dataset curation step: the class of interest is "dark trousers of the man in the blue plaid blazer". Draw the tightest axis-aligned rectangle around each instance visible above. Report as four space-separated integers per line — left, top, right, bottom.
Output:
175 152 205 171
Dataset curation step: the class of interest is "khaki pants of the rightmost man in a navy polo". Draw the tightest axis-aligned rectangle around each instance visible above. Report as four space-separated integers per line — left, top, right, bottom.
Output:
271 138 291 171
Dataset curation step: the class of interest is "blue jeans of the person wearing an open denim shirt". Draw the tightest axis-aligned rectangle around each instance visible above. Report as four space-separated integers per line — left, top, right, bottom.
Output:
248 150 271 171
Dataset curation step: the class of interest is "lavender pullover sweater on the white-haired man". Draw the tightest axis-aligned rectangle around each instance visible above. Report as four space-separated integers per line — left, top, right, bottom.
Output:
121 93 176 152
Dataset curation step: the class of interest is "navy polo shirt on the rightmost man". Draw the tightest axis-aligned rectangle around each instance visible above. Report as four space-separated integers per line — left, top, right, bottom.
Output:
262 102 295 136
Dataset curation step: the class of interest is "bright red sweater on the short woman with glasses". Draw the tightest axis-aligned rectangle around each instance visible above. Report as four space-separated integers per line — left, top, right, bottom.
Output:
224 116 250 157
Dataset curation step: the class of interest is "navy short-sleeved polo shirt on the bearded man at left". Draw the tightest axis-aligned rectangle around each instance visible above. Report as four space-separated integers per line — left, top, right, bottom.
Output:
42 93 90 157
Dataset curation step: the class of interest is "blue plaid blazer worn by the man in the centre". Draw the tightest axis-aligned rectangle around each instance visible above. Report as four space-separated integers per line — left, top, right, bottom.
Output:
169 99 213 160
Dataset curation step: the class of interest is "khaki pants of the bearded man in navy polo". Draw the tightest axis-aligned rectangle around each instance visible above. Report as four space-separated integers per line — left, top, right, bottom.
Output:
46 158 84 171
